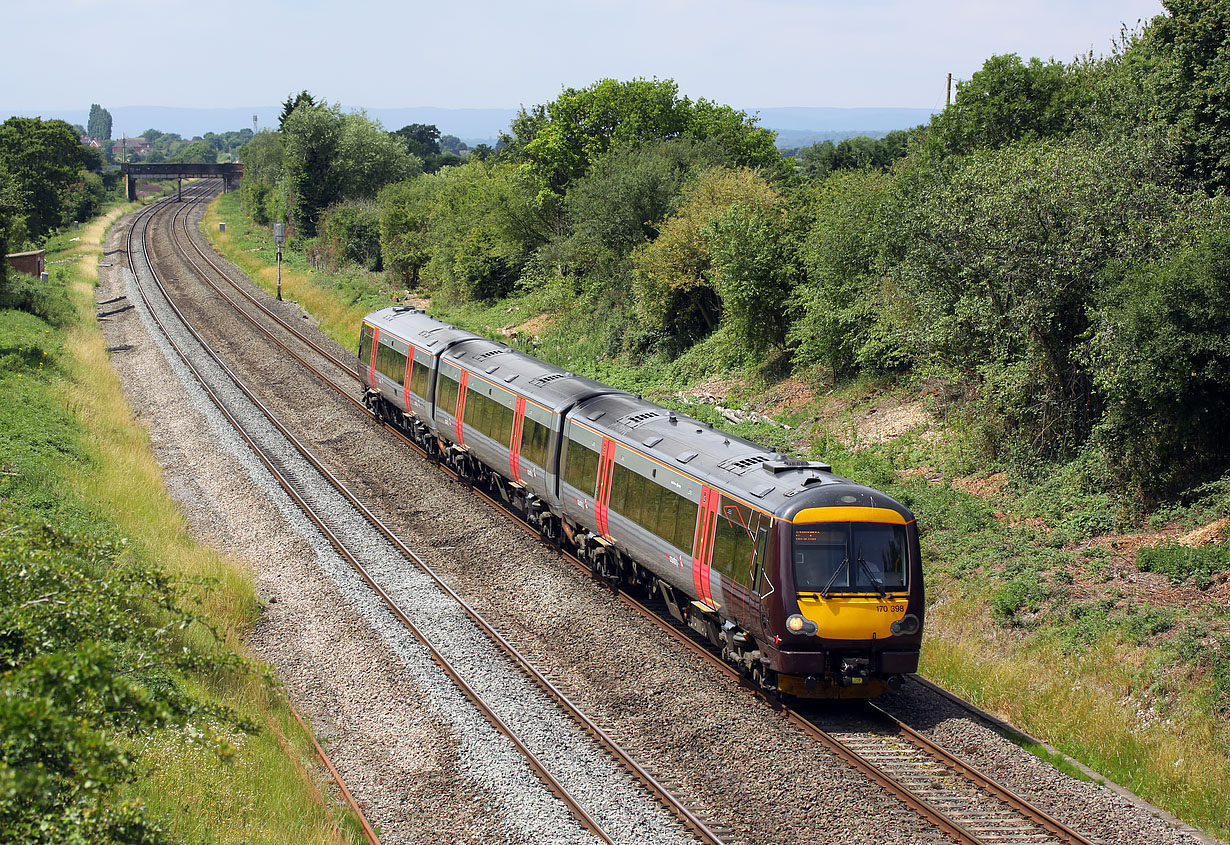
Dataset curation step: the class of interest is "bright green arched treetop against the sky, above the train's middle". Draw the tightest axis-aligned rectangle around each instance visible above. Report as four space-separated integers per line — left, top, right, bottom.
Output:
504 79 784 208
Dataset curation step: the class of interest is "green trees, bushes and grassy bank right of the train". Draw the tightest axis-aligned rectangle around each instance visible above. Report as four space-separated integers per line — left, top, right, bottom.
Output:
218 0 1230 835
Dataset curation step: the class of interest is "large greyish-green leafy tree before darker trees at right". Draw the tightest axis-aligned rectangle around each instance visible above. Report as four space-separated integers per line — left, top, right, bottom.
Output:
888 138 1189 456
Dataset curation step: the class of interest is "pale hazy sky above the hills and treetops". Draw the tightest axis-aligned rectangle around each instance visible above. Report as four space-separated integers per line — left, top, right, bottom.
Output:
0 0 1162 109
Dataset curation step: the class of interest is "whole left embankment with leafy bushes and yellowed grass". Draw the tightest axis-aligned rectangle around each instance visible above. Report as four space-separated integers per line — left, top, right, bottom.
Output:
0 205 366 843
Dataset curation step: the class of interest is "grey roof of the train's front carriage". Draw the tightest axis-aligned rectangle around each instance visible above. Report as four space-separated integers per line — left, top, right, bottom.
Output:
571 394 913 520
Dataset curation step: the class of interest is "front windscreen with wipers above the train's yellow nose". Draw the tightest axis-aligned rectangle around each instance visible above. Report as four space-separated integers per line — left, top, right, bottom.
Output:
793 523 908 595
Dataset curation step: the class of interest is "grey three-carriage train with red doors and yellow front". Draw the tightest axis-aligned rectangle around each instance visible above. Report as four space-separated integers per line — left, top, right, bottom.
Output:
358 305 924 699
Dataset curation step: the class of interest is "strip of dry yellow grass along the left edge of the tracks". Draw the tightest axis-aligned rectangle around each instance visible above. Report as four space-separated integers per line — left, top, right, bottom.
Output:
54 205 358 845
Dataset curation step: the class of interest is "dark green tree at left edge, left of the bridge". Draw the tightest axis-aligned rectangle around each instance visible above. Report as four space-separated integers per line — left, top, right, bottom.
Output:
0 117 93 240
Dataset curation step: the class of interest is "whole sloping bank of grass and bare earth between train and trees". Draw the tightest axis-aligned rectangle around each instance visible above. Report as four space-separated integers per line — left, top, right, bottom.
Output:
204 188 1230 838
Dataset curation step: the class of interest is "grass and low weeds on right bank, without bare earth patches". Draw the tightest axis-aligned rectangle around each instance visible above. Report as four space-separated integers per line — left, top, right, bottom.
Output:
209 199 1230 838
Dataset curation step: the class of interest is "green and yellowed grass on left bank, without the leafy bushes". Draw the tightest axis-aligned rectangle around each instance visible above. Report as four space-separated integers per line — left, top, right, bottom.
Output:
0 205 371 845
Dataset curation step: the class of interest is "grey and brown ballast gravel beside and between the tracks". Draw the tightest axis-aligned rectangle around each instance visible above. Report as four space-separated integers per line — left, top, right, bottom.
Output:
86 195 1220 843
